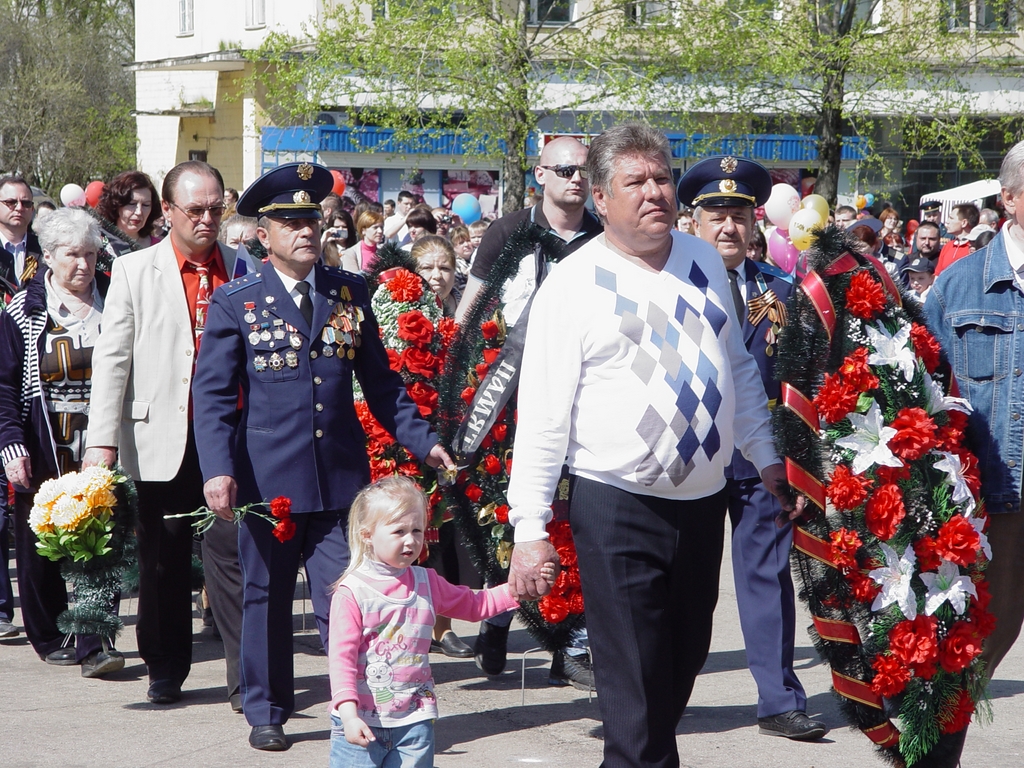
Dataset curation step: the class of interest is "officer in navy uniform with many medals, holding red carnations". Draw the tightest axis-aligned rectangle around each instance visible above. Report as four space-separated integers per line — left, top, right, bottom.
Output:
193 163 453 751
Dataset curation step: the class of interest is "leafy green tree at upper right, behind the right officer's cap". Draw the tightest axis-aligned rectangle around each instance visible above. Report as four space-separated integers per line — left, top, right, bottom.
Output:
650 0 1024 203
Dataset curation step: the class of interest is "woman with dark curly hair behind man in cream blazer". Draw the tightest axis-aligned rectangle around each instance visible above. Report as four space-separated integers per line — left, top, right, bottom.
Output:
95 171 160 271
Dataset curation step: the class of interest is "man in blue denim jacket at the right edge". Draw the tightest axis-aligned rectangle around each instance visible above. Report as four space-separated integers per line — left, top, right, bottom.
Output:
925 141 1024 676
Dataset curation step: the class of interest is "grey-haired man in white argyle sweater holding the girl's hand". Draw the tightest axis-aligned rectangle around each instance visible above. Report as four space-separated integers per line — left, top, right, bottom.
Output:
509 123 803 768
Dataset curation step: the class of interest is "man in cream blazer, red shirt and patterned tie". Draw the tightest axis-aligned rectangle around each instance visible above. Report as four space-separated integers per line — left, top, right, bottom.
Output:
84 161 258 711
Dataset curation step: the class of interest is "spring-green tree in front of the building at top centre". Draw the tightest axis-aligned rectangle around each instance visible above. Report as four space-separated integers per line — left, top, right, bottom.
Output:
251 0 671 212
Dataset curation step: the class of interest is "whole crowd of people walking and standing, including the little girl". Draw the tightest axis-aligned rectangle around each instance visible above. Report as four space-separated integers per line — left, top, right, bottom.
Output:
0 123 1024 768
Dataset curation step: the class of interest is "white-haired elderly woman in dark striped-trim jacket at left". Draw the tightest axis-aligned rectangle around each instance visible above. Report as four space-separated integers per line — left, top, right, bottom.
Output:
0 208 125 677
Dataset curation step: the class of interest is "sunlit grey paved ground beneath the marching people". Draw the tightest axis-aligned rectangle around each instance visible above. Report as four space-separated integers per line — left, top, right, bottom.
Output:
0 553 1024 768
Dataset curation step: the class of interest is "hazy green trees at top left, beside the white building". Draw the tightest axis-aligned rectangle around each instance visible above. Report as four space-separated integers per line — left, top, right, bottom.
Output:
0 0 135 194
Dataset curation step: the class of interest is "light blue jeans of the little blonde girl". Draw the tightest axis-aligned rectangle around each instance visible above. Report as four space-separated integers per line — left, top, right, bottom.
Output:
330 715 434 768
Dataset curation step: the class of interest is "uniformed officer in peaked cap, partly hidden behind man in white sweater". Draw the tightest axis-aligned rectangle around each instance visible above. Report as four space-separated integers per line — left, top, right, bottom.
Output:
678 157 826 739
